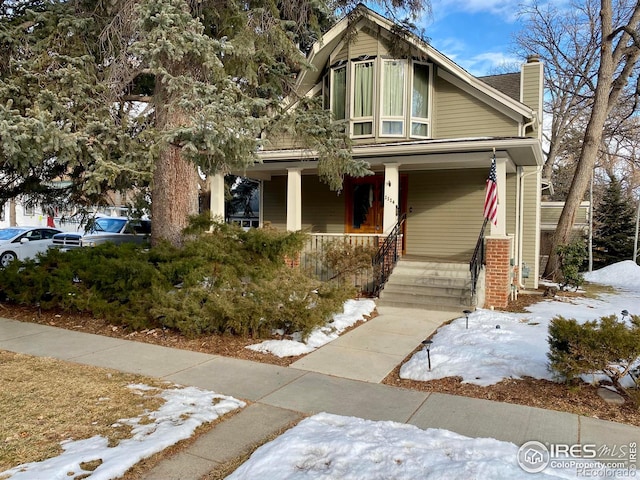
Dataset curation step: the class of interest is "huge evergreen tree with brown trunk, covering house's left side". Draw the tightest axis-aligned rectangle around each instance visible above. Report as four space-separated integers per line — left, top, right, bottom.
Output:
0 0 428 244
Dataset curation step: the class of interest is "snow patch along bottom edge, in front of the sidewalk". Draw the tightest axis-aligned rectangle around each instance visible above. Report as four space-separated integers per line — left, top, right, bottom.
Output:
227 413 584 480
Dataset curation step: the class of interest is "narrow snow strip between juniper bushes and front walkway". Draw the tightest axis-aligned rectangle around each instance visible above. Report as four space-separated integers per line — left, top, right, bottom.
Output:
246 299 376 357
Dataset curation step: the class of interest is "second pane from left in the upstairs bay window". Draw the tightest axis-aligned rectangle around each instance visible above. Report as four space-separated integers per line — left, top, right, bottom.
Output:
351 60 376 137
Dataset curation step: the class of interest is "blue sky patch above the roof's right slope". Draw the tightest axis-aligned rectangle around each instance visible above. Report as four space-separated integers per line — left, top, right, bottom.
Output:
420 0 524 75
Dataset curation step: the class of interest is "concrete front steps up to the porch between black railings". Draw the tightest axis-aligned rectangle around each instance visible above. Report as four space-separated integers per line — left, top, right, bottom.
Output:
378 259 472 310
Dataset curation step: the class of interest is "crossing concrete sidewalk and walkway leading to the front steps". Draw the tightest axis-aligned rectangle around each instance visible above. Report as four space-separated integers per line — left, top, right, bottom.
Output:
0 309 640 480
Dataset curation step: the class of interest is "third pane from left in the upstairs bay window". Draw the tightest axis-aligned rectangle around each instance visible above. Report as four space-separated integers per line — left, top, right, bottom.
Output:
380 60 407 137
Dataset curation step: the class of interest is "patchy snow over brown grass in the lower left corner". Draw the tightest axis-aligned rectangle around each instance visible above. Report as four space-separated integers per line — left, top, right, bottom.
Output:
0 385 246 480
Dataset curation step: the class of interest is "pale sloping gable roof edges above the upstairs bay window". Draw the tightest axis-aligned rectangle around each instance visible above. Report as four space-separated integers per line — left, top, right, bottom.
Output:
297 4 533 119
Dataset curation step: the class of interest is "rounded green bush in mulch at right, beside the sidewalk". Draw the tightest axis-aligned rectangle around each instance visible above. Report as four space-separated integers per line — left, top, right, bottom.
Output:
548 315 640 396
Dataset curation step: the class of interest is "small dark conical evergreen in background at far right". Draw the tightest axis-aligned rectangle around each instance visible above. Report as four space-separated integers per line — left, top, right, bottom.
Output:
593 176 635 268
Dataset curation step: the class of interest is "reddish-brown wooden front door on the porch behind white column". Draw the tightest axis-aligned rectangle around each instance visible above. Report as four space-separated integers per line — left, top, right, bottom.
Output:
346 175 384 233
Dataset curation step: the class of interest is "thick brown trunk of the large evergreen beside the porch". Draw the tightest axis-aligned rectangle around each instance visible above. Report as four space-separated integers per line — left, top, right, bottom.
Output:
151 80 198 246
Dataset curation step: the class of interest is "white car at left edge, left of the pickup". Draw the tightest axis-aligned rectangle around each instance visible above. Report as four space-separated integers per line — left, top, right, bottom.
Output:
0 227 61 267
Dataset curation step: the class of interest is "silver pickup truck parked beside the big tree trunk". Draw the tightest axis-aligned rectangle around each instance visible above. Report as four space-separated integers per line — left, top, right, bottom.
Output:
51 217 151 250
